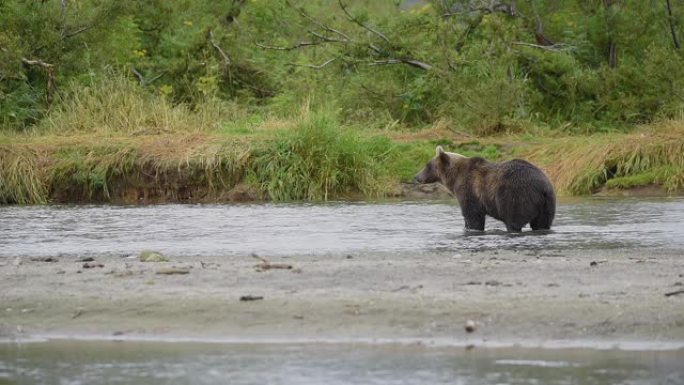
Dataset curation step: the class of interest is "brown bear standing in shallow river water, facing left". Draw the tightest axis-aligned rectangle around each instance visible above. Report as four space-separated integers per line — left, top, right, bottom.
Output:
415 146 556 232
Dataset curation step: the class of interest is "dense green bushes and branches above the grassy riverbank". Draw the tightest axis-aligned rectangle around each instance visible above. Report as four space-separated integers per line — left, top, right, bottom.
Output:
0 0 684 134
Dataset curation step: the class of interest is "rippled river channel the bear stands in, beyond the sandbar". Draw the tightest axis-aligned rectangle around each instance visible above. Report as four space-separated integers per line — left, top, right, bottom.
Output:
0 198 684 257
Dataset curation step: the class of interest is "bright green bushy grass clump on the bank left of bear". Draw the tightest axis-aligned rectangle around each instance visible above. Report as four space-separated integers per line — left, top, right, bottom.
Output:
250 112 393 201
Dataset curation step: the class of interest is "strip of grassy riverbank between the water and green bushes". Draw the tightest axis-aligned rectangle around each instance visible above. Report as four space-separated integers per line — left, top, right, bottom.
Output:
0 108 684 204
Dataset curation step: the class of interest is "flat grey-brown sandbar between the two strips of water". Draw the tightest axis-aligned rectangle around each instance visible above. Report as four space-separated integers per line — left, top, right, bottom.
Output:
0 250 684 344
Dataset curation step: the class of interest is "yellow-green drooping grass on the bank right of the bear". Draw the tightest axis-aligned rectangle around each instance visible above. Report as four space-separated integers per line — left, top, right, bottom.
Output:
529 121 684 195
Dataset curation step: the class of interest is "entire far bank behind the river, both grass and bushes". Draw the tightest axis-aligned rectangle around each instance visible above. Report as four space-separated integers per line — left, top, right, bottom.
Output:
0 0 684 204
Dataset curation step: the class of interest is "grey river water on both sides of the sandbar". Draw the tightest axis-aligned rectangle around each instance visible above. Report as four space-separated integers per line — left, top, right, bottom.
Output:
0 198 684 385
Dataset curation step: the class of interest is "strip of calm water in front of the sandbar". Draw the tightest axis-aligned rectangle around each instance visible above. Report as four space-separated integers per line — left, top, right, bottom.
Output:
0 341 684 385
